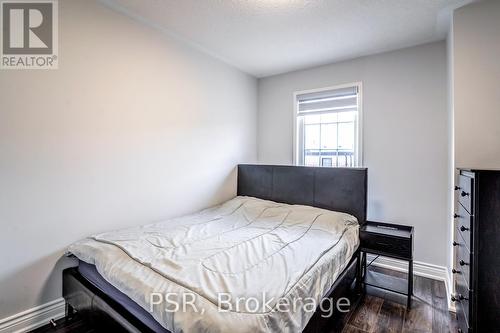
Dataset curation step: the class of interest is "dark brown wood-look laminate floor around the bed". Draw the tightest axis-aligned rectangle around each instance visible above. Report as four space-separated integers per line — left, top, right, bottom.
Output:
34 267 457 333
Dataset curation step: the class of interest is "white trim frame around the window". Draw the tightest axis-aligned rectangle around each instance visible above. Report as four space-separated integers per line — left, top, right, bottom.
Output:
293 81 363 167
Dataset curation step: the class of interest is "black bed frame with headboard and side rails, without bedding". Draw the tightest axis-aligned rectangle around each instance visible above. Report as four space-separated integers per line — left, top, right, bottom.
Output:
63 164 367 333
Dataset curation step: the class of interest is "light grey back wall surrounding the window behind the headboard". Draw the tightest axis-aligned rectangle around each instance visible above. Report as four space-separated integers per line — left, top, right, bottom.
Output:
258 42 450 266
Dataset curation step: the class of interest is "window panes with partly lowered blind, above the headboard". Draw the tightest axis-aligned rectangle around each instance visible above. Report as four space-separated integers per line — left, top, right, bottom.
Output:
295 84 361 167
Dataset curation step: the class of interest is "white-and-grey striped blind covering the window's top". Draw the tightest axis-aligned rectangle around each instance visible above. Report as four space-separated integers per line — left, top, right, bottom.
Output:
297 87 358 116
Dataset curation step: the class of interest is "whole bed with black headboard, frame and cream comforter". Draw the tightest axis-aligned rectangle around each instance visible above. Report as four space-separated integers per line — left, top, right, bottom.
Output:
63 165 367 332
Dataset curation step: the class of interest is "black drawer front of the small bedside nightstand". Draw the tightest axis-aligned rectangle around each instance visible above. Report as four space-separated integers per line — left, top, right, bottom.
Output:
359 233 412 259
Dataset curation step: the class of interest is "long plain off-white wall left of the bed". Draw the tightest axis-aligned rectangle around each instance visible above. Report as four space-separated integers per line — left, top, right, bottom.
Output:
0 0 257 318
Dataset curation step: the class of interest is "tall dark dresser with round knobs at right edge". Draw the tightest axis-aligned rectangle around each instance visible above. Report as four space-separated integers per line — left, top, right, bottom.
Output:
452 169 500 333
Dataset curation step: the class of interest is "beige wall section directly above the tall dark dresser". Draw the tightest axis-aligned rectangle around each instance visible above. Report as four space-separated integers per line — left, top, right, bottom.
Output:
453 0 500 169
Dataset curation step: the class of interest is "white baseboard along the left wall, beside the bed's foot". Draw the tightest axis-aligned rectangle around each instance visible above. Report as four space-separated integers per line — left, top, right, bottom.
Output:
0 298 65 333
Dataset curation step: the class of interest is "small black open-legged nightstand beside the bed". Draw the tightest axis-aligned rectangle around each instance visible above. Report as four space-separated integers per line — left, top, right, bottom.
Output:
359 221 413 308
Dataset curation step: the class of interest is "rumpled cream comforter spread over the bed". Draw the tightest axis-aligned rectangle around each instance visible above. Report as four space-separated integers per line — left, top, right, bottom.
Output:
68 197 359 332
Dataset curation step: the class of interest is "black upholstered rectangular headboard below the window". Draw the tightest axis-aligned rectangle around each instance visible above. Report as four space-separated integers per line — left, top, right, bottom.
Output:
238 164 368 224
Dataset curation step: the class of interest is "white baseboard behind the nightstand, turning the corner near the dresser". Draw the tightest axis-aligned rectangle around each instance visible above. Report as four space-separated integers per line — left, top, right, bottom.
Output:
366 254 455 312
